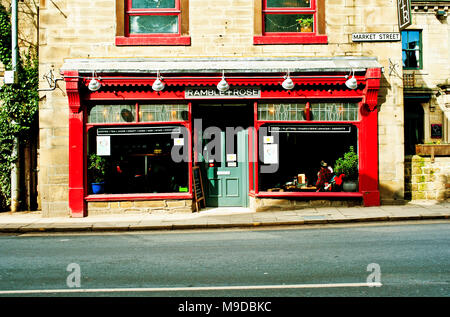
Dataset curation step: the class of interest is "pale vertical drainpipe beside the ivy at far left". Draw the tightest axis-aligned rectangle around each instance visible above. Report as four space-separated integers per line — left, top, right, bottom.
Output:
11 0 20 212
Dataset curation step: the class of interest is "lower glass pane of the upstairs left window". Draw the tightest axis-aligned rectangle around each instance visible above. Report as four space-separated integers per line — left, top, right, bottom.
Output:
130 15 178 34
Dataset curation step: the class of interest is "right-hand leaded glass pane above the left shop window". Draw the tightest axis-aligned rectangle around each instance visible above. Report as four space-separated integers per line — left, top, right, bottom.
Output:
139 104 188 122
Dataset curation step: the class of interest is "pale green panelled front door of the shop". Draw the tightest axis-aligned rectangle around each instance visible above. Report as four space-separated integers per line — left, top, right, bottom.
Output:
203 130 248 207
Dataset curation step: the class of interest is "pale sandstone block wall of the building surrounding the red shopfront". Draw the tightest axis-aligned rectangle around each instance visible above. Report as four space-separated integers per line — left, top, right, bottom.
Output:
39 0 406 216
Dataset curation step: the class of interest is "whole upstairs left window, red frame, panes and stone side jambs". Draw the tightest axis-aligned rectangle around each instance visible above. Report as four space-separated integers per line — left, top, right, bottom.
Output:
116 0 190 45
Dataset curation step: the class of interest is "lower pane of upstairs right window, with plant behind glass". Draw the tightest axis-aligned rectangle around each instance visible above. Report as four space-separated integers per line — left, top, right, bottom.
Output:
264 14 314 32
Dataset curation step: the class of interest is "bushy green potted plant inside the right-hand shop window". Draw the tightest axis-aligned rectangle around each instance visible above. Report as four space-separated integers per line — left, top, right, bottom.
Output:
334 146 358 192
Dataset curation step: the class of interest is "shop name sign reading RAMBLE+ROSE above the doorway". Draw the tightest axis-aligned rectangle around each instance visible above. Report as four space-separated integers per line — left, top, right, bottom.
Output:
185 87 261 99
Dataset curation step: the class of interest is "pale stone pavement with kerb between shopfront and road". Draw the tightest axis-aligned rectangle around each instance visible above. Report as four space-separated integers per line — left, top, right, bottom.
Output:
0 201 450 233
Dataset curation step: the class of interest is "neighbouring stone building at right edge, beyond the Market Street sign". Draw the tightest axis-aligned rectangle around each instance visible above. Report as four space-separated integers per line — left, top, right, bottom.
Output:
403 0 450 201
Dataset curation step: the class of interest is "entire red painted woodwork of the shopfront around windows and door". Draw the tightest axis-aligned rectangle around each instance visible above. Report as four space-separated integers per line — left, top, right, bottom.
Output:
64 68 381 217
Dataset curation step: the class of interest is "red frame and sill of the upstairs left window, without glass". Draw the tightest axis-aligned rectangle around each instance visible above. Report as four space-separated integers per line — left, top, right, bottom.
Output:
116 0 191 45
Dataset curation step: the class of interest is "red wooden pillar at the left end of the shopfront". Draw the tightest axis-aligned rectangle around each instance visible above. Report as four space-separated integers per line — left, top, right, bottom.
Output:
64 71 87 218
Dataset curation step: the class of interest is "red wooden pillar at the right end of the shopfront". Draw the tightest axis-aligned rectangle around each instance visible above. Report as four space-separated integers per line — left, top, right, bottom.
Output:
359 68 381 207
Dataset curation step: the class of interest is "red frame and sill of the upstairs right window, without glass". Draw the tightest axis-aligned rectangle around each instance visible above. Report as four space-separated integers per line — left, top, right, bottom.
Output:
253 0 328 44
